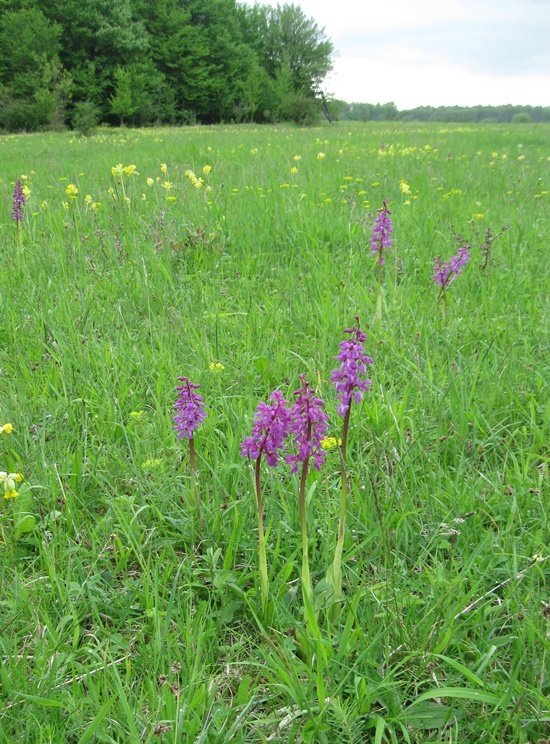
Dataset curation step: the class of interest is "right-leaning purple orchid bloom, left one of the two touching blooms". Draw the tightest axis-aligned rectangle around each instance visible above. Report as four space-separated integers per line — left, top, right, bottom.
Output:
241 390 290 468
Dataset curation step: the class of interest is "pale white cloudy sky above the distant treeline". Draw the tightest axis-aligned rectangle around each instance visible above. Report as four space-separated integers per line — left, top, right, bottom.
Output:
250 0 550 109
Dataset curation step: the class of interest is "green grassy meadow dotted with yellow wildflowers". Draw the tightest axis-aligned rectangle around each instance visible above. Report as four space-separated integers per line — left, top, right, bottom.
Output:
0 123 550 744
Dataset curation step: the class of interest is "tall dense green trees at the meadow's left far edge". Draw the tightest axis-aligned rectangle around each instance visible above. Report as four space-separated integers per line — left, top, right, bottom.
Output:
0 0 333 131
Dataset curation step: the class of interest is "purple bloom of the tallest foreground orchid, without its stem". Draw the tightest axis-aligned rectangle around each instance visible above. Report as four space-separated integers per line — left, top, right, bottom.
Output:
330 315 373 417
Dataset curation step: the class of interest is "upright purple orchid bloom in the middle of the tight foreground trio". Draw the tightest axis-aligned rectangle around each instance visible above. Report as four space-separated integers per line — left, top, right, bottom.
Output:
286 375 328 473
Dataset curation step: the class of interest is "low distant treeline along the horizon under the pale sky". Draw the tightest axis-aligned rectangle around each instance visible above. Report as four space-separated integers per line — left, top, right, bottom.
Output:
340 101 550 124
